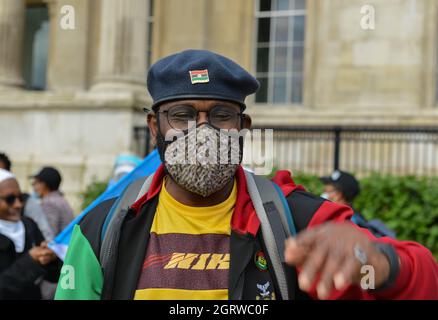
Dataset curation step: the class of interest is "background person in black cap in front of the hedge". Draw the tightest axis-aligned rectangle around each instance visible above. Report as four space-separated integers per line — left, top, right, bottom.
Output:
320 170 396 238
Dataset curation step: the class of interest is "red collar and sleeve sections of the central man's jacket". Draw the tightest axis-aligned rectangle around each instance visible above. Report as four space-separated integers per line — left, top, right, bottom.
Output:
132 166 438 300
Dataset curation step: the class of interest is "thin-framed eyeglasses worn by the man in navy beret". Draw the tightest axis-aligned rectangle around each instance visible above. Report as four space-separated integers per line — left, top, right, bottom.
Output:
158 105 243 130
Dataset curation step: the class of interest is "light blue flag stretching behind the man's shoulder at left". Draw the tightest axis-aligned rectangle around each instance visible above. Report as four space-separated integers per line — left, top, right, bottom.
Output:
49 149 161 260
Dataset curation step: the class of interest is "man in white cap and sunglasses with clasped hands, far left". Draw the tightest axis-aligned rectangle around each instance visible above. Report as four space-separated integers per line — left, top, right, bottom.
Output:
0 169 61 300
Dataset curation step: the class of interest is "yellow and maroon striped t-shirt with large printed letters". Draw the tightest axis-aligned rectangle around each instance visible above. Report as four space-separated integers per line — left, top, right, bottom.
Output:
134 181 237 300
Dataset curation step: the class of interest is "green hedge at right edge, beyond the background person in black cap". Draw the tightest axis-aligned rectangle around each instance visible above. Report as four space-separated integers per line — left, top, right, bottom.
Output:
354 173 438 257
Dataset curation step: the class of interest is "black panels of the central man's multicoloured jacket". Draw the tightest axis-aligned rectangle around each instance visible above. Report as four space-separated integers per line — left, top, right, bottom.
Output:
69 191 323 300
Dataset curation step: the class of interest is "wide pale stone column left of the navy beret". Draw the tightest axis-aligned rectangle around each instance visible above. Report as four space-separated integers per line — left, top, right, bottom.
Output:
92 0 148 92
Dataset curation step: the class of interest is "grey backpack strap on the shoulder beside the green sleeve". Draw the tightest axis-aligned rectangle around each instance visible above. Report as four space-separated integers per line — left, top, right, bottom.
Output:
99 174 154 299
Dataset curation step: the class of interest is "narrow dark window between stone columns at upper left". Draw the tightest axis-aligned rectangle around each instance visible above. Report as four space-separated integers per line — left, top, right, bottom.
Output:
23 5 49 90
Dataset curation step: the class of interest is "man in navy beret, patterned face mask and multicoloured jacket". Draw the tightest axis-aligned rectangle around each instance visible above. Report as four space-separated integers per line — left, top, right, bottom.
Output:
57 50 438 300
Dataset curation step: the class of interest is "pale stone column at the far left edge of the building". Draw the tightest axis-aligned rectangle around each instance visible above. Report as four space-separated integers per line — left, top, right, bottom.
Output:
0 0 25 90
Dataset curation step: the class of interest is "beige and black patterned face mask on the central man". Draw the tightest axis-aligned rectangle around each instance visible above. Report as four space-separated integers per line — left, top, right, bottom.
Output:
158 124 241 197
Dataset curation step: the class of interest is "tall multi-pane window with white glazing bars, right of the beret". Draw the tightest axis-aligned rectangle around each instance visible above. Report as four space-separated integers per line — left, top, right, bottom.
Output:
256 0 306 103
